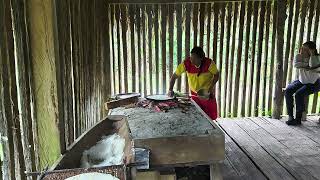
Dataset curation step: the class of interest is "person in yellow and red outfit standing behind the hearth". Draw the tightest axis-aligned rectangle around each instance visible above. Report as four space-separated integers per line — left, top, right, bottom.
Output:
168 47 219 120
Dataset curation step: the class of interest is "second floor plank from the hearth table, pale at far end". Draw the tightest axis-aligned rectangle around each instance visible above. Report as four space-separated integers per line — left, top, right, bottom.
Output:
219 120 296 180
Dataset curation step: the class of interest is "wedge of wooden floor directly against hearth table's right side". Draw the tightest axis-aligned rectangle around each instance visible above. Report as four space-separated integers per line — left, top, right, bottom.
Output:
221 135 267 180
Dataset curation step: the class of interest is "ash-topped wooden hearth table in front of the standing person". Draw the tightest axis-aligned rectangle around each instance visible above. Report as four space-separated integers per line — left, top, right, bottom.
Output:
110 100 225 179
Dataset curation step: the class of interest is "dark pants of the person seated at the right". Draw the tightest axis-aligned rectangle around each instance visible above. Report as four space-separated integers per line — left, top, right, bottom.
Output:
285 79 320 117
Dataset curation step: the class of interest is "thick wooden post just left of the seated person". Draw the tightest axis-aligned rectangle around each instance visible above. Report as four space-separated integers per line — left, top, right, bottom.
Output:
272 1 287 119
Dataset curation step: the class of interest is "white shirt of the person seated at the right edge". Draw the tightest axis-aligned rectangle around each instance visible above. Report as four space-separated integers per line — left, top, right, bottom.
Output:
294 54 320 84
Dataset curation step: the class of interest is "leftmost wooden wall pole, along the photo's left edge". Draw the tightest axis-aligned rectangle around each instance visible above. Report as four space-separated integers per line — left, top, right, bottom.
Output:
0 1 15 180
